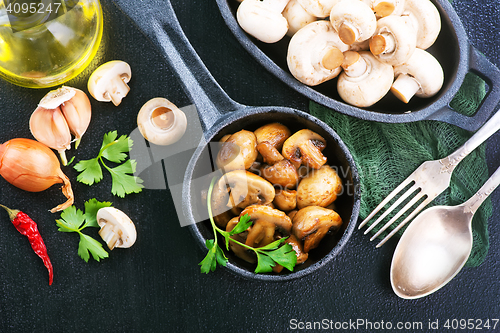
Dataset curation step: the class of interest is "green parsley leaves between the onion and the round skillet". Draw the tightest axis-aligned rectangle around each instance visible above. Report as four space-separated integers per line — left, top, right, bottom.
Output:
74 131 144 198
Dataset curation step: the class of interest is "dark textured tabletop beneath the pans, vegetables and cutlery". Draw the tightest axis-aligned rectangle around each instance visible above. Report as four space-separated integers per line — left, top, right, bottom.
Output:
0 0 500 332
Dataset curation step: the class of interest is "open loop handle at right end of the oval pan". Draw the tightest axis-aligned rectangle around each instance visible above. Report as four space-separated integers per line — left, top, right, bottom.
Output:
429 45 500 132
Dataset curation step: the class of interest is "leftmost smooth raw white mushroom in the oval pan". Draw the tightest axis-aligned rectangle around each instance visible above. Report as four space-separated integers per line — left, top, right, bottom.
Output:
236 0 289 43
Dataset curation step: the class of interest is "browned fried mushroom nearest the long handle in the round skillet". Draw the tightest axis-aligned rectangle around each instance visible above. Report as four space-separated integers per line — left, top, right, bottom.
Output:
216 130 258 172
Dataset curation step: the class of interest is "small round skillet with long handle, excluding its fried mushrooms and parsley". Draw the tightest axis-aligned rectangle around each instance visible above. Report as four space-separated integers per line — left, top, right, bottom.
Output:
115 0 360 281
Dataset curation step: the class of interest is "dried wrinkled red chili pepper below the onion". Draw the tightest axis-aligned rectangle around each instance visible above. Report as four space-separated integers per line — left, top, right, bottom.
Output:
0 205 54 285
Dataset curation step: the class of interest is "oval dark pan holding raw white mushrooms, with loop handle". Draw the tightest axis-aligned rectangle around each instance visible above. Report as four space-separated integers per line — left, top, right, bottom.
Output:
217 0 500 131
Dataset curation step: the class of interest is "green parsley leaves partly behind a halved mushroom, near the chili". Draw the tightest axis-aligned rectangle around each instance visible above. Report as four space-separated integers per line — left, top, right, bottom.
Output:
56 199 111 262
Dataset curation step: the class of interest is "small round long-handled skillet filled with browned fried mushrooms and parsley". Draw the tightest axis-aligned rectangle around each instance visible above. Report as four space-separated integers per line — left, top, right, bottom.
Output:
117 0 360 281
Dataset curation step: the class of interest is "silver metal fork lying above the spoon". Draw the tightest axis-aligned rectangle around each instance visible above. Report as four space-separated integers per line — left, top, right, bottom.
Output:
359 111 500 247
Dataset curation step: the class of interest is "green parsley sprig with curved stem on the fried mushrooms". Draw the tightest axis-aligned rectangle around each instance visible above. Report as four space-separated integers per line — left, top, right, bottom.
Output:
200 177 297 274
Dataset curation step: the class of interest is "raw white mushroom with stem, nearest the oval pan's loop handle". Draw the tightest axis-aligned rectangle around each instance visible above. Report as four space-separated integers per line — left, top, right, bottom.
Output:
391 48 444 103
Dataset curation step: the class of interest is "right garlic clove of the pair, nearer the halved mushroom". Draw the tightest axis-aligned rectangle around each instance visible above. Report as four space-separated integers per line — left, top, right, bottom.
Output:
60 88 92 149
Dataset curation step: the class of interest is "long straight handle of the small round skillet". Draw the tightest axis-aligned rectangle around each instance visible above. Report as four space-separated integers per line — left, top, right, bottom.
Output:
113 0 243 132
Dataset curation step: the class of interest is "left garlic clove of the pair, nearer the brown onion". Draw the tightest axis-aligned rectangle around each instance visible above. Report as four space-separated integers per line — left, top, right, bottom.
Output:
30 106 71 165
